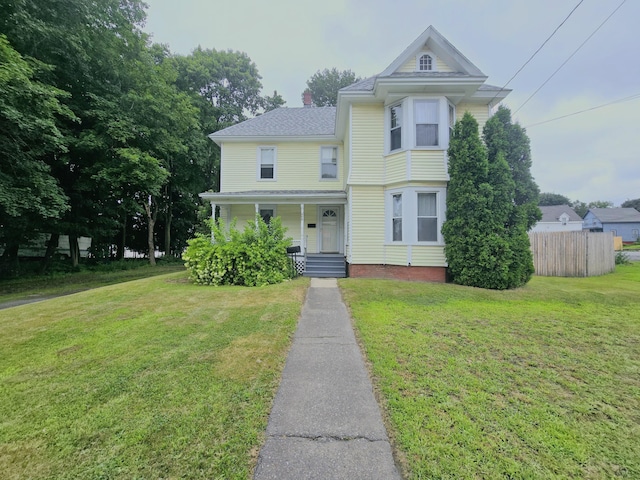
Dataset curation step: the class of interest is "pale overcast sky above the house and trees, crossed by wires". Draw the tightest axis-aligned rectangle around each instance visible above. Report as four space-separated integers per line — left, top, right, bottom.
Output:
145 0 640 206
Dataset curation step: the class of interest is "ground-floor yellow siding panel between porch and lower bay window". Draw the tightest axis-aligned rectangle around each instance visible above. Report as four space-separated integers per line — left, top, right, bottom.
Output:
350 186 384 264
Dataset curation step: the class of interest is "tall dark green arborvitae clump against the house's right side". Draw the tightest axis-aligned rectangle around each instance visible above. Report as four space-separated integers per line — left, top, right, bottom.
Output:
442 112 537 290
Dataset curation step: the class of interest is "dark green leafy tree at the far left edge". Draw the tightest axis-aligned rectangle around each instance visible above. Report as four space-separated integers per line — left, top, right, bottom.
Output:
0 35 74 273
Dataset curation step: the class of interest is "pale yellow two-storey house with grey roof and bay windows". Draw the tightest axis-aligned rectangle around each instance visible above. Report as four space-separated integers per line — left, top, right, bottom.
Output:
201 27 510 281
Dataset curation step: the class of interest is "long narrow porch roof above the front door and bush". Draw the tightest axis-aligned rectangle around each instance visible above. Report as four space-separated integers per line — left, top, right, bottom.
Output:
200 190 347 205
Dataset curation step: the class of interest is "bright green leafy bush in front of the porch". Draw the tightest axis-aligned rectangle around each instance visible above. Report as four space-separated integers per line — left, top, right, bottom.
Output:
182 215 293 287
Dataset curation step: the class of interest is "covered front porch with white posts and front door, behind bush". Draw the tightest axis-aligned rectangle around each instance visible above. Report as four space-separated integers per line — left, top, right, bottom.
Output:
200 190 348 271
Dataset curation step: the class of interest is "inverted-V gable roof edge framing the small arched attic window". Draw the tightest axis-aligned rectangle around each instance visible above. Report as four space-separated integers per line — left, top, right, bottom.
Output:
380 25 486 77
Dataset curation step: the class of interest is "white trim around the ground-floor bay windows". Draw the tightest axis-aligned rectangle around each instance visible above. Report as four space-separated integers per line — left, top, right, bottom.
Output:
385 187 447 246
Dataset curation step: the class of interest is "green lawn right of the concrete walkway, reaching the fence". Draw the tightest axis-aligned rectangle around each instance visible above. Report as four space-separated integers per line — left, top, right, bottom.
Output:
340 264 640 479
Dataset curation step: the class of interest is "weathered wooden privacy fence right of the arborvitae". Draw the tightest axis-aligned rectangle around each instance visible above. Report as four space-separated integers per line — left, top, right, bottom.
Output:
529 232 616 277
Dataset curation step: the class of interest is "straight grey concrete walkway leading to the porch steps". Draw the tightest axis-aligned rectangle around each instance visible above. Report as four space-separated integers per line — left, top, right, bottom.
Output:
254 278 401 480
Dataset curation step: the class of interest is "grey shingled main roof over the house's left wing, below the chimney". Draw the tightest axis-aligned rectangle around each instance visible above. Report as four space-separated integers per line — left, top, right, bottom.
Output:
209 107 336 141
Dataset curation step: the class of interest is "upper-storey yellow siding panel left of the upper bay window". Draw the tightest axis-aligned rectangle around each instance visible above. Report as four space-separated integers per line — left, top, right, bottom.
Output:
349 104 384 185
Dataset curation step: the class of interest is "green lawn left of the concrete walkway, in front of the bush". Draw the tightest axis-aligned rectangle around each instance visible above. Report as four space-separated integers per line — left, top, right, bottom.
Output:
0 272 308 479
